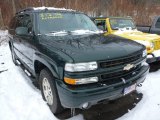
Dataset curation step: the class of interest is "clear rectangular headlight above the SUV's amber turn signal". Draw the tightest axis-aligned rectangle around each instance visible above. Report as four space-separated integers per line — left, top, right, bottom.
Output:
64 62 98 72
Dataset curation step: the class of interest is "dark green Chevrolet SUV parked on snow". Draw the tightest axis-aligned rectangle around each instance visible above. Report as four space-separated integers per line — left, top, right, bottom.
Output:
9 7 149 113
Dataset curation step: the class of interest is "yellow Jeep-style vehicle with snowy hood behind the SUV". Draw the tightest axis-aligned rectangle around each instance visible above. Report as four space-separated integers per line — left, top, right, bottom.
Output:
92 17 160 63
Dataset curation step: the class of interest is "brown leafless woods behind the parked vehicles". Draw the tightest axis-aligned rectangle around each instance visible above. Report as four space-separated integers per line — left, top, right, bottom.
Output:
0 0 160 28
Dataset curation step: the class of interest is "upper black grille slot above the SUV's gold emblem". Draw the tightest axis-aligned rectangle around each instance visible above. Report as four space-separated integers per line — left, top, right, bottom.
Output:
99 54 142 68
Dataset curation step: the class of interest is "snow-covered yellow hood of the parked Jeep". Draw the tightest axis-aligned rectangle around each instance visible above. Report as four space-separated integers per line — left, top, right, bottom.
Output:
113 30 160 41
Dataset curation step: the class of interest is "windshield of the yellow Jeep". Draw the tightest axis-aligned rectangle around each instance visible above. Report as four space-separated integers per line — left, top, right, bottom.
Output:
110 18 136 30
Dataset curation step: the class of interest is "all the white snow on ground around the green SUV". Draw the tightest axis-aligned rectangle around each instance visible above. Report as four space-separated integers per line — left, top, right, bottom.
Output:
0 31 160 120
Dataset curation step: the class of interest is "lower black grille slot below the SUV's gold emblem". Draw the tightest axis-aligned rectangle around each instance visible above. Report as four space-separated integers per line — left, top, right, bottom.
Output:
100 65 141 85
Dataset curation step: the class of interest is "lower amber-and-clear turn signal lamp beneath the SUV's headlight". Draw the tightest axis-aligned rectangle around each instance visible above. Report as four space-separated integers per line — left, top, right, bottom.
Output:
64 77 98 85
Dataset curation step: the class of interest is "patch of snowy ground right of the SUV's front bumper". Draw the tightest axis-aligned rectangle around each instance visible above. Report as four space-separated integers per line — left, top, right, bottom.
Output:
118 70 160 120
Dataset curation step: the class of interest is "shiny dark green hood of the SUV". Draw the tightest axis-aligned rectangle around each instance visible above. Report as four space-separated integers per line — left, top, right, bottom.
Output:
39 34 145 62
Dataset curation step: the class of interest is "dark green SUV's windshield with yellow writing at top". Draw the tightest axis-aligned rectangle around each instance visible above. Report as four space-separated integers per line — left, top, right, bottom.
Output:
38 12 98 34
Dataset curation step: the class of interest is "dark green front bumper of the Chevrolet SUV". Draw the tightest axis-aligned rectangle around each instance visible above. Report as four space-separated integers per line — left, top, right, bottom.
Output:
56 65 149 108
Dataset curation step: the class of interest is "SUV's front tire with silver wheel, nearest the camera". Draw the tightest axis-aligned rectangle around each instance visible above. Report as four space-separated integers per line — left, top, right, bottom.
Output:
39 68 63 114
